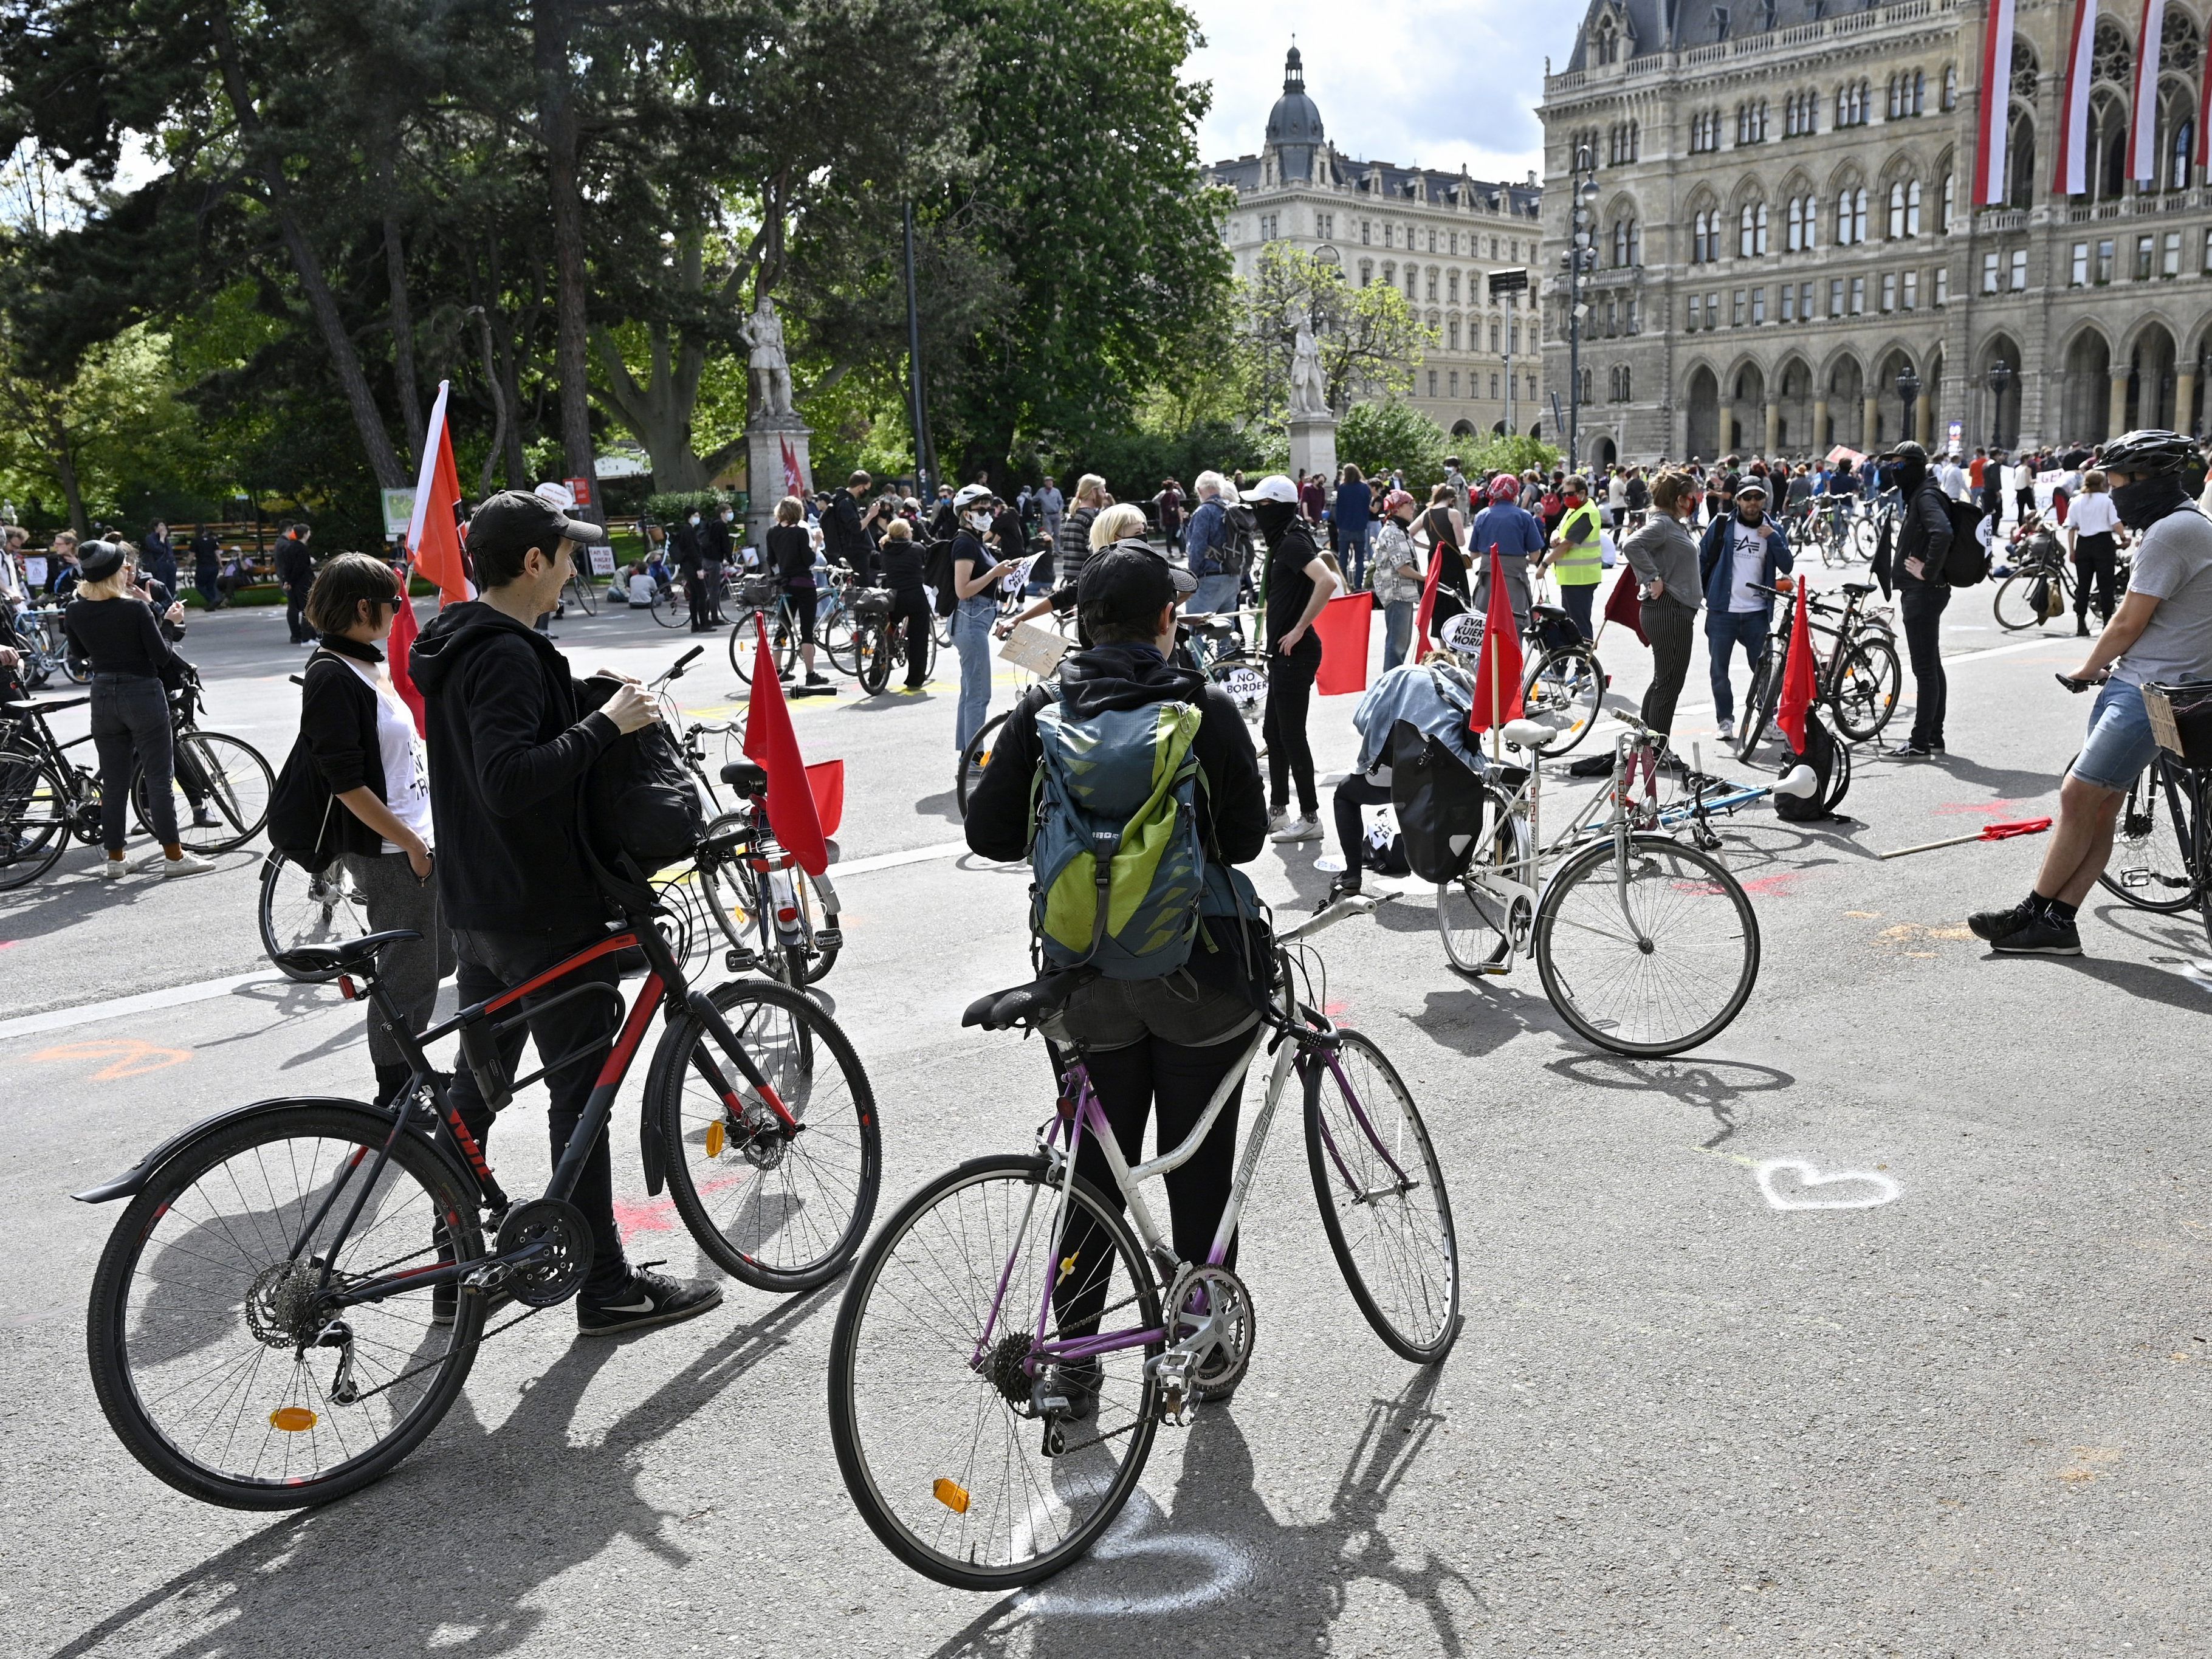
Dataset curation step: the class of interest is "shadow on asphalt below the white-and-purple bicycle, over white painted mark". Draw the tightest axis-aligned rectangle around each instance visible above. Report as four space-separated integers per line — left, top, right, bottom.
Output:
929 1369 1489 1659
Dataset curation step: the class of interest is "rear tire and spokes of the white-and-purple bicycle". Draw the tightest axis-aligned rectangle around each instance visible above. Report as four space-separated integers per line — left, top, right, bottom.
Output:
829 1155 1161 1590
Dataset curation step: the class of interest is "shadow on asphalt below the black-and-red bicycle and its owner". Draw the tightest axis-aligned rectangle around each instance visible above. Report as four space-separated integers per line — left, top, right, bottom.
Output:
51 1283 839 1659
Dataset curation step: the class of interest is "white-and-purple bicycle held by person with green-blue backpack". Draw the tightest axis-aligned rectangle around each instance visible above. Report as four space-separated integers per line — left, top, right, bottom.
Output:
829 898 1460 1590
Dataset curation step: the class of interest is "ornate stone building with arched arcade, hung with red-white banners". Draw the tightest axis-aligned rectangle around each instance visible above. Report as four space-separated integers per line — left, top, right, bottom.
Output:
1542 0 2212 462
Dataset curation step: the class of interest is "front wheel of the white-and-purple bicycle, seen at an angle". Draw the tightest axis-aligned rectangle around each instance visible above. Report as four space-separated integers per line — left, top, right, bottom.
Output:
1305 1031 1460 1365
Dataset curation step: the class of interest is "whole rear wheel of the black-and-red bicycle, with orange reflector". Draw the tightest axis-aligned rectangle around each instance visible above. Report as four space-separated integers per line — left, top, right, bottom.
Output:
86 1102 484 1508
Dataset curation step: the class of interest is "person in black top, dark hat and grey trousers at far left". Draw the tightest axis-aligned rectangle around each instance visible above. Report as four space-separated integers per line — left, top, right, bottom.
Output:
62 542 215 881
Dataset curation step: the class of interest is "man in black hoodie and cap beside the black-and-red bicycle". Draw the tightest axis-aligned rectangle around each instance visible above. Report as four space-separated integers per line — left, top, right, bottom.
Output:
409 489 721 1336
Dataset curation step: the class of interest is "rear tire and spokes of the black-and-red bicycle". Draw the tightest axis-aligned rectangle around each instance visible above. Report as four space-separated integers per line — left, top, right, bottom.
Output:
86 1102 484 1511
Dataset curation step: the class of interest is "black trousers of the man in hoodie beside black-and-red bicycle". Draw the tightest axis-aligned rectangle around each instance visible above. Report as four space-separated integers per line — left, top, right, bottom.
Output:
453 927 630 1303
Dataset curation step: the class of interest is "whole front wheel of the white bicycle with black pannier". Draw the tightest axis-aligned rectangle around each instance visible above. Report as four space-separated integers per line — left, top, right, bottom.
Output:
1535 834 1759 1055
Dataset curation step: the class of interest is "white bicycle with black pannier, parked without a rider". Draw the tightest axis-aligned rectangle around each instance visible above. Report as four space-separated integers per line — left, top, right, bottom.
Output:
1435 715 1760 1055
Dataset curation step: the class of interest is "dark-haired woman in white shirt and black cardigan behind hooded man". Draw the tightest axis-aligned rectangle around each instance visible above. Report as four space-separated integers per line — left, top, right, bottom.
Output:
298 553 456 1106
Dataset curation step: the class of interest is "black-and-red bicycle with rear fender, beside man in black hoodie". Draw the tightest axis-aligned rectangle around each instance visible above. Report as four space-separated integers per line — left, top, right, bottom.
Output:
75 889 881 1508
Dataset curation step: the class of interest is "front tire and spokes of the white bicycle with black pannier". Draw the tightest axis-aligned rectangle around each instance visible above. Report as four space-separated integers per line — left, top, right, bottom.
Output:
1535 834 1759 1055
